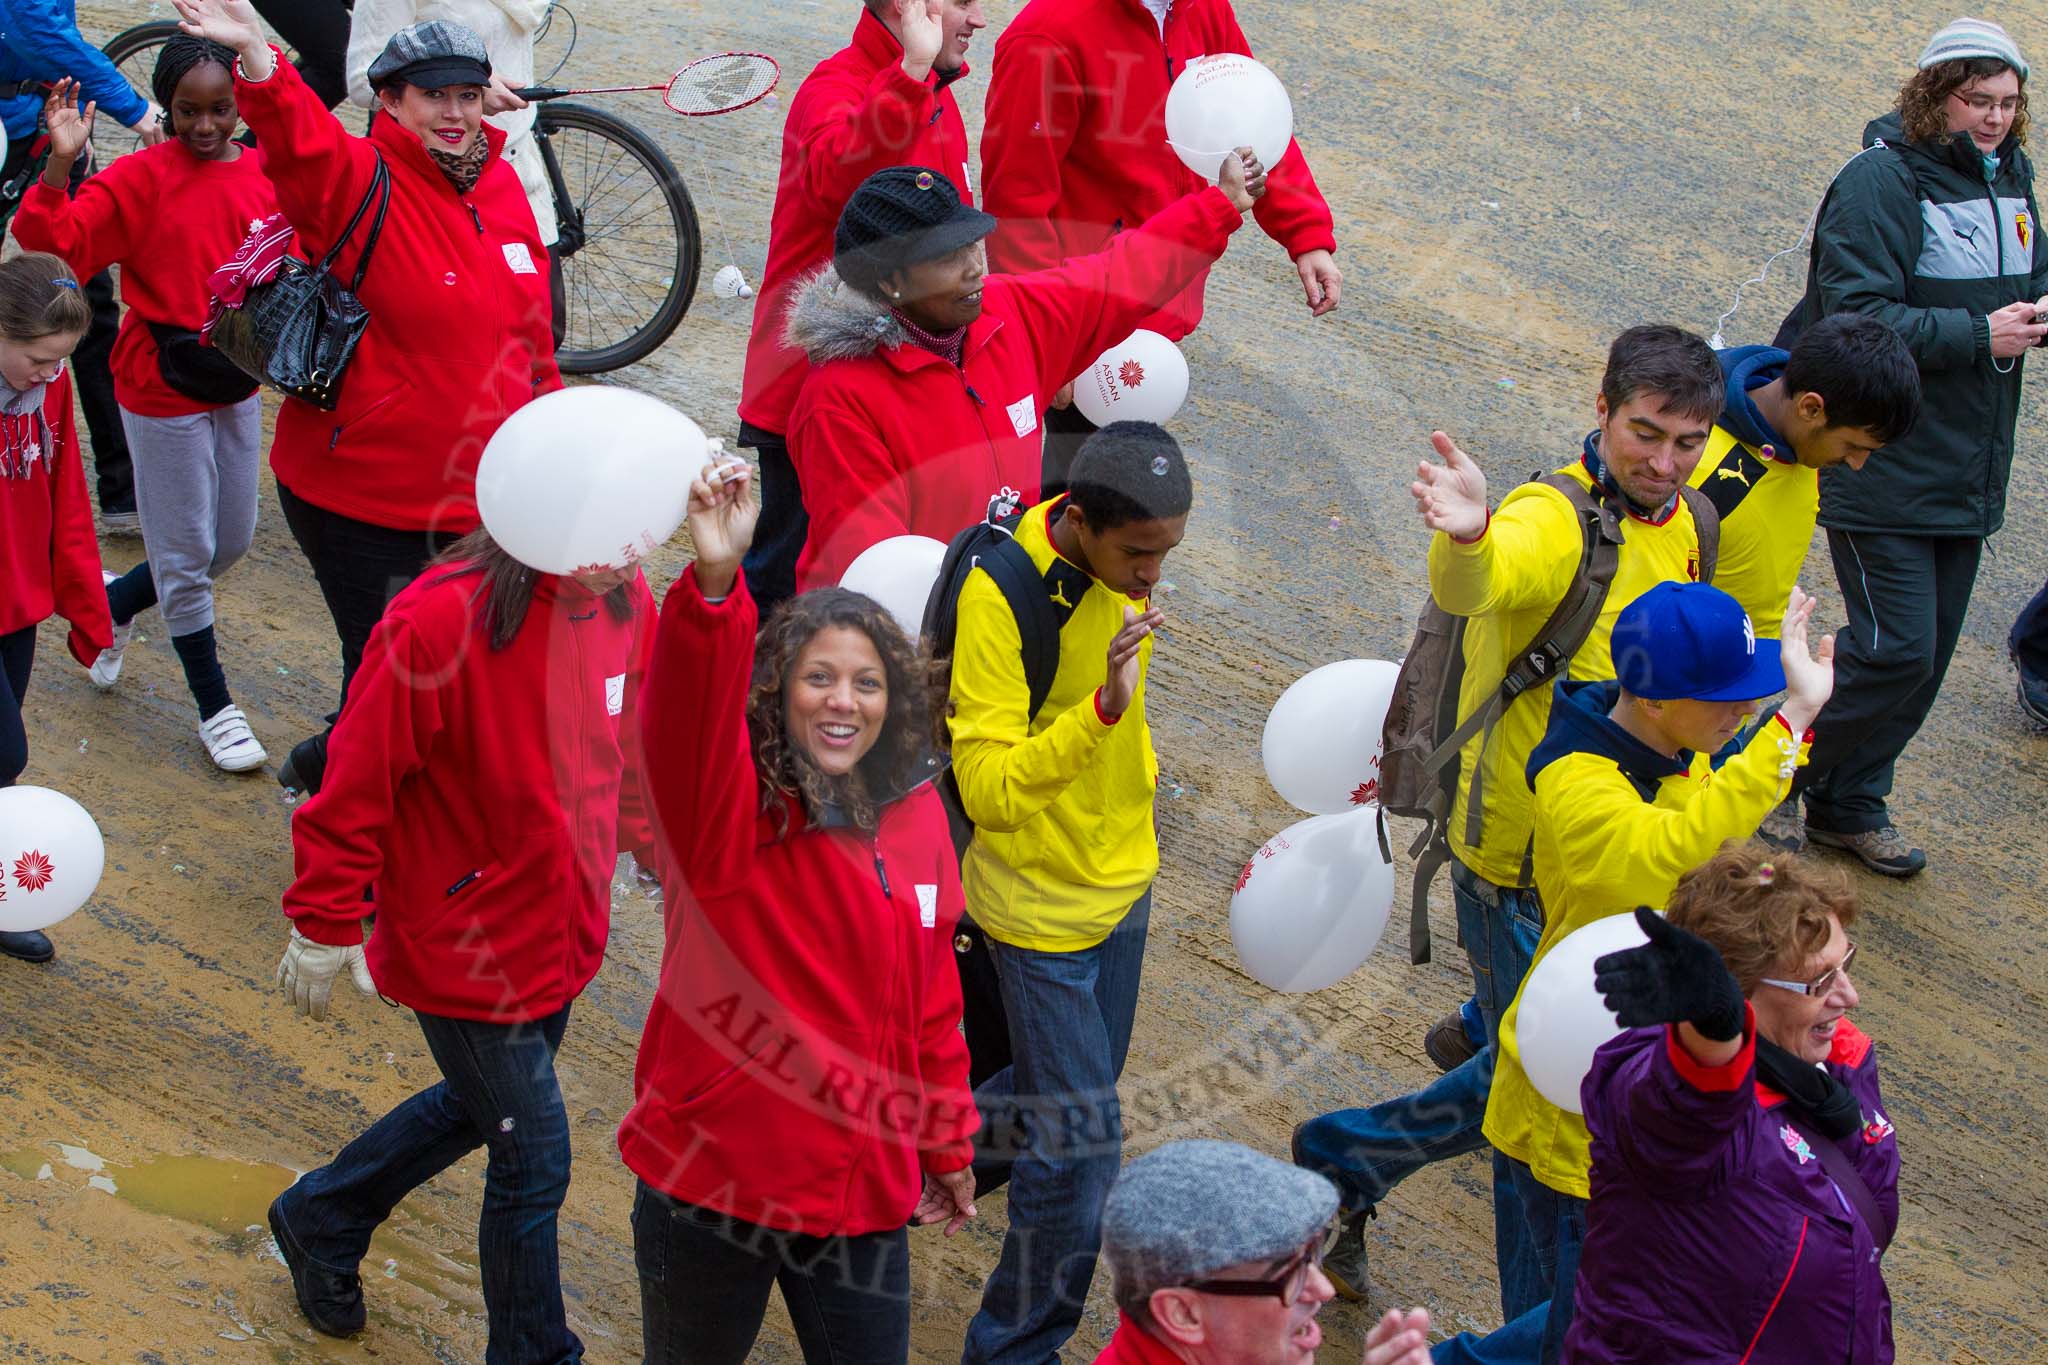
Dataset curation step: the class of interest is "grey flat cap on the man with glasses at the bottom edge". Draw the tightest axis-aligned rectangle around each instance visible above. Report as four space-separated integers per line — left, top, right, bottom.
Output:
1102 1140 1337 1302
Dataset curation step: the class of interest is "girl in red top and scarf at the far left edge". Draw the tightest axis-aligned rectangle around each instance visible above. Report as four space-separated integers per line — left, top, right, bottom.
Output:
0 252 115 962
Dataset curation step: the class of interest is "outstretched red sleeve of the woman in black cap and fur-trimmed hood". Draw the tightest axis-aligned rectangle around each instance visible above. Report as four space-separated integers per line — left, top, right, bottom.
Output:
1006 186 1243 393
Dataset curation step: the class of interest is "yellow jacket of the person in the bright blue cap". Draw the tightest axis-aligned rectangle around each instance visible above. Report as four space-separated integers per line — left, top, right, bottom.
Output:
1485 684 1806 1199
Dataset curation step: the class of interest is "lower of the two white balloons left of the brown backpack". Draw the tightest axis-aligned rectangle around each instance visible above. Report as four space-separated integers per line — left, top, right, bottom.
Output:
1231 808 1395 990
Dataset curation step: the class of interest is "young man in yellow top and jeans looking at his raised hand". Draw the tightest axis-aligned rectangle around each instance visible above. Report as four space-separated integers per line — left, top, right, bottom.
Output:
950 422 1194 1361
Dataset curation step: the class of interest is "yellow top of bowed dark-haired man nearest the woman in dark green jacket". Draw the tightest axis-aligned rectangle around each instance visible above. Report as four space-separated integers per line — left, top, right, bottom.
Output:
1692 426 1821 641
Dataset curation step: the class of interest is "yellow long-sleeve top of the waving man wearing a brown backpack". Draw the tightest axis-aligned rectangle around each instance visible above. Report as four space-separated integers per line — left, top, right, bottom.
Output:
1430 463 1700 886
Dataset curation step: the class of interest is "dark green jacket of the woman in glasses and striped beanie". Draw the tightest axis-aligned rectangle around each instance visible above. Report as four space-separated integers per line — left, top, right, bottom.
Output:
1778 113 2048 536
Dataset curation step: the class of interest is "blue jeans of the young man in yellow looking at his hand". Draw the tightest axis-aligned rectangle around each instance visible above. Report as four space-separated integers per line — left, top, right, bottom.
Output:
961 890 1151 1365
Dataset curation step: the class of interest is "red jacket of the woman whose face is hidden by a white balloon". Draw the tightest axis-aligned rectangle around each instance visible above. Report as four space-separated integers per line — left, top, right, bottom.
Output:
285 567 653 1023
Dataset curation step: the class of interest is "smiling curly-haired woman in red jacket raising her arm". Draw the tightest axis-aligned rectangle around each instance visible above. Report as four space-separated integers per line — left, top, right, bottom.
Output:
618 467 977 1365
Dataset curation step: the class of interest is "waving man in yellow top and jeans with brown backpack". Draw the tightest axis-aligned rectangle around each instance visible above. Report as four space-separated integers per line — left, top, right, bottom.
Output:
1294 325 1722 1322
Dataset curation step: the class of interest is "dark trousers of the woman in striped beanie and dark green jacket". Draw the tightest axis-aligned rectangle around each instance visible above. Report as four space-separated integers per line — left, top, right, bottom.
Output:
1794 530 1985 835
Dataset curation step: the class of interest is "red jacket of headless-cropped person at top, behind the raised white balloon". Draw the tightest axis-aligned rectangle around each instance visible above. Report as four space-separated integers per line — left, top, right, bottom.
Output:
981 0 1337 341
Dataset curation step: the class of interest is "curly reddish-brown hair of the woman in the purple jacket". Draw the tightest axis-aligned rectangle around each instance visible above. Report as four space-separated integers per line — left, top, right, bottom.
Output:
1665 843 1855 995
